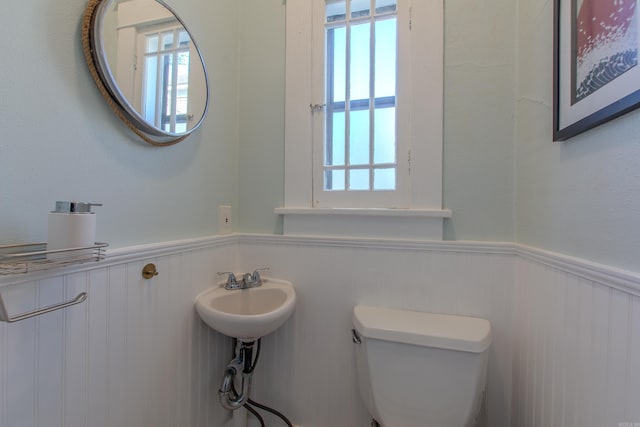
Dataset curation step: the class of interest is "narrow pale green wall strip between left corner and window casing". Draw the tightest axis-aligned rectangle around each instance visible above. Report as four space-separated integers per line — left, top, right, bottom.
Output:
236 0 285 233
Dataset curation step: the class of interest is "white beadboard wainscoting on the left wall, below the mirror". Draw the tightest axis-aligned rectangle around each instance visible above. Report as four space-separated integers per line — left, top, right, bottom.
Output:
0 239 236 427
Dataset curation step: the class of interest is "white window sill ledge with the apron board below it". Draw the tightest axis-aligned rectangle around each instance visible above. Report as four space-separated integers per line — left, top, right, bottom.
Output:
275 208 452 240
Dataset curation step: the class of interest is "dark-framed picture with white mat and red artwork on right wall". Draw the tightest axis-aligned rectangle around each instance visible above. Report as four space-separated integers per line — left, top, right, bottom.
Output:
553 0 640 141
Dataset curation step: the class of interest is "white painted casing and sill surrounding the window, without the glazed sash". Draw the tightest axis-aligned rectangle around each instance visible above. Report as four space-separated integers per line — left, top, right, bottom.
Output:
276 0 451 239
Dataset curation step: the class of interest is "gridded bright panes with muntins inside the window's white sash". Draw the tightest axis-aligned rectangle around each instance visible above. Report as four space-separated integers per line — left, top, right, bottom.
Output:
323 0 398 191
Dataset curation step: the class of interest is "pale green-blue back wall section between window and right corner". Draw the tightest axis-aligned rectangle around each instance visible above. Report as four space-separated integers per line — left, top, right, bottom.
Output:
443 0 517 241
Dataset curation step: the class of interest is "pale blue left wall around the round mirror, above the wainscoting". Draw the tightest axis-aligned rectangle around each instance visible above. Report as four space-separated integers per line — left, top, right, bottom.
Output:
0 0 238 246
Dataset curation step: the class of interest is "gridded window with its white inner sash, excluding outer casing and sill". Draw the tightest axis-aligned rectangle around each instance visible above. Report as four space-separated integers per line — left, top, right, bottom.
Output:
312 0 409 207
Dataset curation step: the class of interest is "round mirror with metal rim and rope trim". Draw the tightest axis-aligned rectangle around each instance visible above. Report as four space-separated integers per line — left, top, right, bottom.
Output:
82 0 209 145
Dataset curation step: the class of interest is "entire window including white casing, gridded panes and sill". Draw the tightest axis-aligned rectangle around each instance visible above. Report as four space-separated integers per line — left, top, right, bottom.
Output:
276 0 451 239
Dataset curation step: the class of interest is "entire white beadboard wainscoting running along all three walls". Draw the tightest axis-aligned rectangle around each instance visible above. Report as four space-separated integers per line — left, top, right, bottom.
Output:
0 235 640 427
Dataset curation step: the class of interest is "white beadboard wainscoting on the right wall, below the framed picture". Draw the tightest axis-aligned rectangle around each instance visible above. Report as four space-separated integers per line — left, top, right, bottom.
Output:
512 248 640 427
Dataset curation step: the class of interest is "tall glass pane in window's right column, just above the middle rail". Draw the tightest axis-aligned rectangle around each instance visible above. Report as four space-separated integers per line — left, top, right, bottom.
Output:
374 18 396 98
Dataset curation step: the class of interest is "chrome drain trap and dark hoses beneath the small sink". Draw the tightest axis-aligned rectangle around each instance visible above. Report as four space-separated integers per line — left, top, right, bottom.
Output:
218 338 293 427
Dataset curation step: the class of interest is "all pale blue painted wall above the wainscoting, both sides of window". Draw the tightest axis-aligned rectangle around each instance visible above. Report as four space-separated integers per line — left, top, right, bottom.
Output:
0 0 640 271
